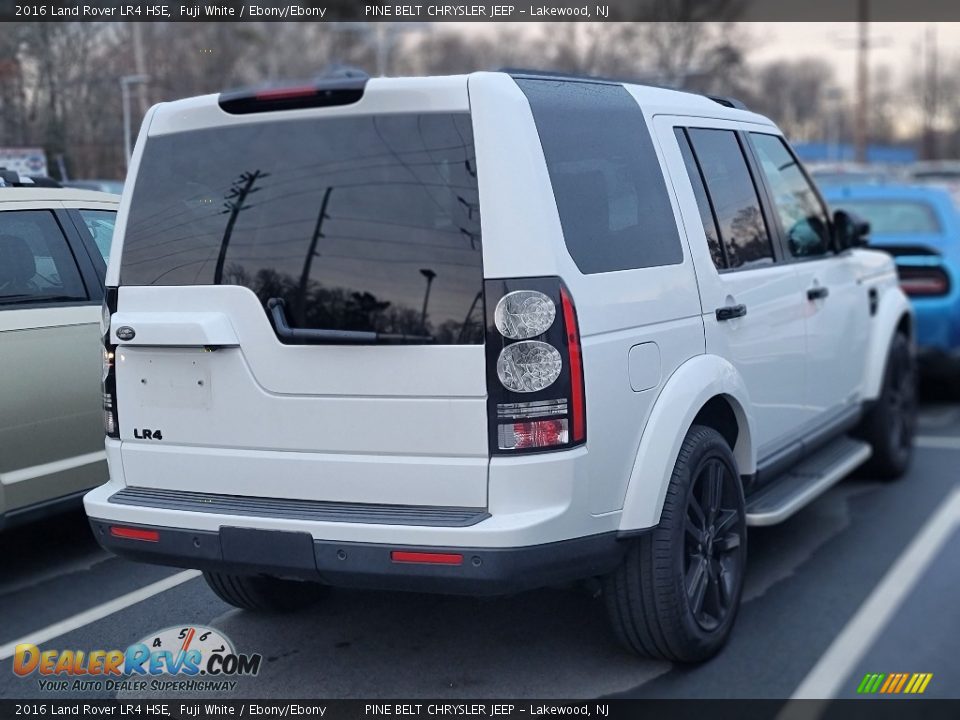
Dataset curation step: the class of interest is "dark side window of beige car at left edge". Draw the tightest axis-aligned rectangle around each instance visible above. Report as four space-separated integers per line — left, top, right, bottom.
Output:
0 210 87 308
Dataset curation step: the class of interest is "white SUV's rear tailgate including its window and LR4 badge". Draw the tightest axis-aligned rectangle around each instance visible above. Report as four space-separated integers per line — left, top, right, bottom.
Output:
108 79 488 507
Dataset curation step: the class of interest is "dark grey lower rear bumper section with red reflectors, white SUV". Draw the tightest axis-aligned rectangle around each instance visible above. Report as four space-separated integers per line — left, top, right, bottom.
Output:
90 518 626 595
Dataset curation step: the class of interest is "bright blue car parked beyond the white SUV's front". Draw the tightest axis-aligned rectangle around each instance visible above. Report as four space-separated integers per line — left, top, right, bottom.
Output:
823 185 960 380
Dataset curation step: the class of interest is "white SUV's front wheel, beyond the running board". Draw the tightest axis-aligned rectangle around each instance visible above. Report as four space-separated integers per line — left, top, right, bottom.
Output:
856 333 917 480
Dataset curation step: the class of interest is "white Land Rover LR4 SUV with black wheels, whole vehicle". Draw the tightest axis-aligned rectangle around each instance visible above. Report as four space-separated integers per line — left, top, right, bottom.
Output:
86 72 915 661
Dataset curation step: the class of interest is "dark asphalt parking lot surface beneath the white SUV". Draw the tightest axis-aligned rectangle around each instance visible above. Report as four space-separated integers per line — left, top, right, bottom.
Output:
0 404 960 699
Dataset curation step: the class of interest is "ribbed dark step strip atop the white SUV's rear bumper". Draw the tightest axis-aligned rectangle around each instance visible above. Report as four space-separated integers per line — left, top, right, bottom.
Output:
108 487 490 527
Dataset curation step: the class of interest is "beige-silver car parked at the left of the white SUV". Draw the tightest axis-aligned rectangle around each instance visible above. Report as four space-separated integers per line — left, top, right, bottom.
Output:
0 183 119 527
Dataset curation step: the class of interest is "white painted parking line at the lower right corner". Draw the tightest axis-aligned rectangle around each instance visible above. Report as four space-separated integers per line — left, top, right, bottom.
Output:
791 489 960 699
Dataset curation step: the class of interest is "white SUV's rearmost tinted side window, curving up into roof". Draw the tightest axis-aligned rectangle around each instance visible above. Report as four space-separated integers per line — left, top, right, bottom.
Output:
517 79 683 274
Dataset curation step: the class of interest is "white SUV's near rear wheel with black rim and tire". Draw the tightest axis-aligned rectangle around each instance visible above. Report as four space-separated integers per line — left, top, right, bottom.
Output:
604 425 747 663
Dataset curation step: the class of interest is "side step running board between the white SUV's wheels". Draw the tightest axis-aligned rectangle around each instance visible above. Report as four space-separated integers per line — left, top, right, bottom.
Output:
747 437 873 525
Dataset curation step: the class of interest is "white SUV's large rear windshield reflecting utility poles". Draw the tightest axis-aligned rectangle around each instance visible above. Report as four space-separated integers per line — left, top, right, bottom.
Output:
120 113 483 344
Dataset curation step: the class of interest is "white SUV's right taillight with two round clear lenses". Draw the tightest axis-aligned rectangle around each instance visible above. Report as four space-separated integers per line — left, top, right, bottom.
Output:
484 277 587 455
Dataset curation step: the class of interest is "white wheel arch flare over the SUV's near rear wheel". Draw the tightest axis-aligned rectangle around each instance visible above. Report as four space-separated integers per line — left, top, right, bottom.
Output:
620 355 756 532
